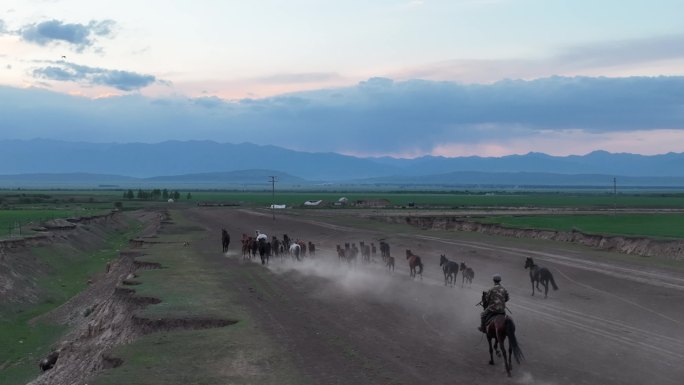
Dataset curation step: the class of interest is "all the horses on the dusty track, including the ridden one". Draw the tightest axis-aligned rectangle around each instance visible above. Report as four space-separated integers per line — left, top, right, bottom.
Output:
221 229 558 377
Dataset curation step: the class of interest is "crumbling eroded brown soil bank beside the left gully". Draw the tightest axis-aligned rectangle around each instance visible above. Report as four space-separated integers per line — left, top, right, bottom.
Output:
24 213 236 385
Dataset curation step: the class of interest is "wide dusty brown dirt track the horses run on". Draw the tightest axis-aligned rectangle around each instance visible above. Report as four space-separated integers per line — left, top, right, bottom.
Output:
183 208 684 384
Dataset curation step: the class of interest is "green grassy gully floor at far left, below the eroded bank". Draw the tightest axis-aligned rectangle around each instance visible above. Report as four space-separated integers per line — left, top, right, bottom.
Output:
0 216 140 385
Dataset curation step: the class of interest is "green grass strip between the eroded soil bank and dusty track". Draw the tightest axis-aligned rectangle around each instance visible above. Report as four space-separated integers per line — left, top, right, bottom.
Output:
93 212 302 385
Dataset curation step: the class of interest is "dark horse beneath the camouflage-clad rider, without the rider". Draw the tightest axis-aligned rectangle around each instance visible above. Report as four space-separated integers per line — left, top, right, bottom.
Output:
480 291 525 377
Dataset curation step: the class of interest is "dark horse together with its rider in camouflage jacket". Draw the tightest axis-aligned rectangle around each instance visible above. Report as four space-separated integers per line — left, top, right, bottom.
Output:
480 275 524 377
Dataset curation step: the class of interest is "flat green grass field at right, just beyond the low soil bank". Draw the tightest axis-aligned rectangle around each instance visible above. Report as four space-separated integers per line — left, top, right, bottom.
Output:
477 213 684 238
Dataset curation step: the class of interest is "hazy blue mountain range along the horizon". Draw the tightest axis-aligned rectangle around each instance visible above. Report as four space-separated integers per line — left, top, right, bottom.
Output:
0 139 684 187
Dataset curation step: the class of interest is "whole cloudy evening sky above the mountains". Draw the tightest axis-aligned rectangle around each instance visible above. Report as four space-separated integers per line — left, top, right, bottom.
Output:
0 0 684 158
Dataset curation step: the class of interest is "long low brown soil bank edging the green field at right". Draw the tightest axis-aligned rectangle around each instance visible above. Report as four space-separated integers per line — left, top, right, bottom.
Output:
372 216 684 260
